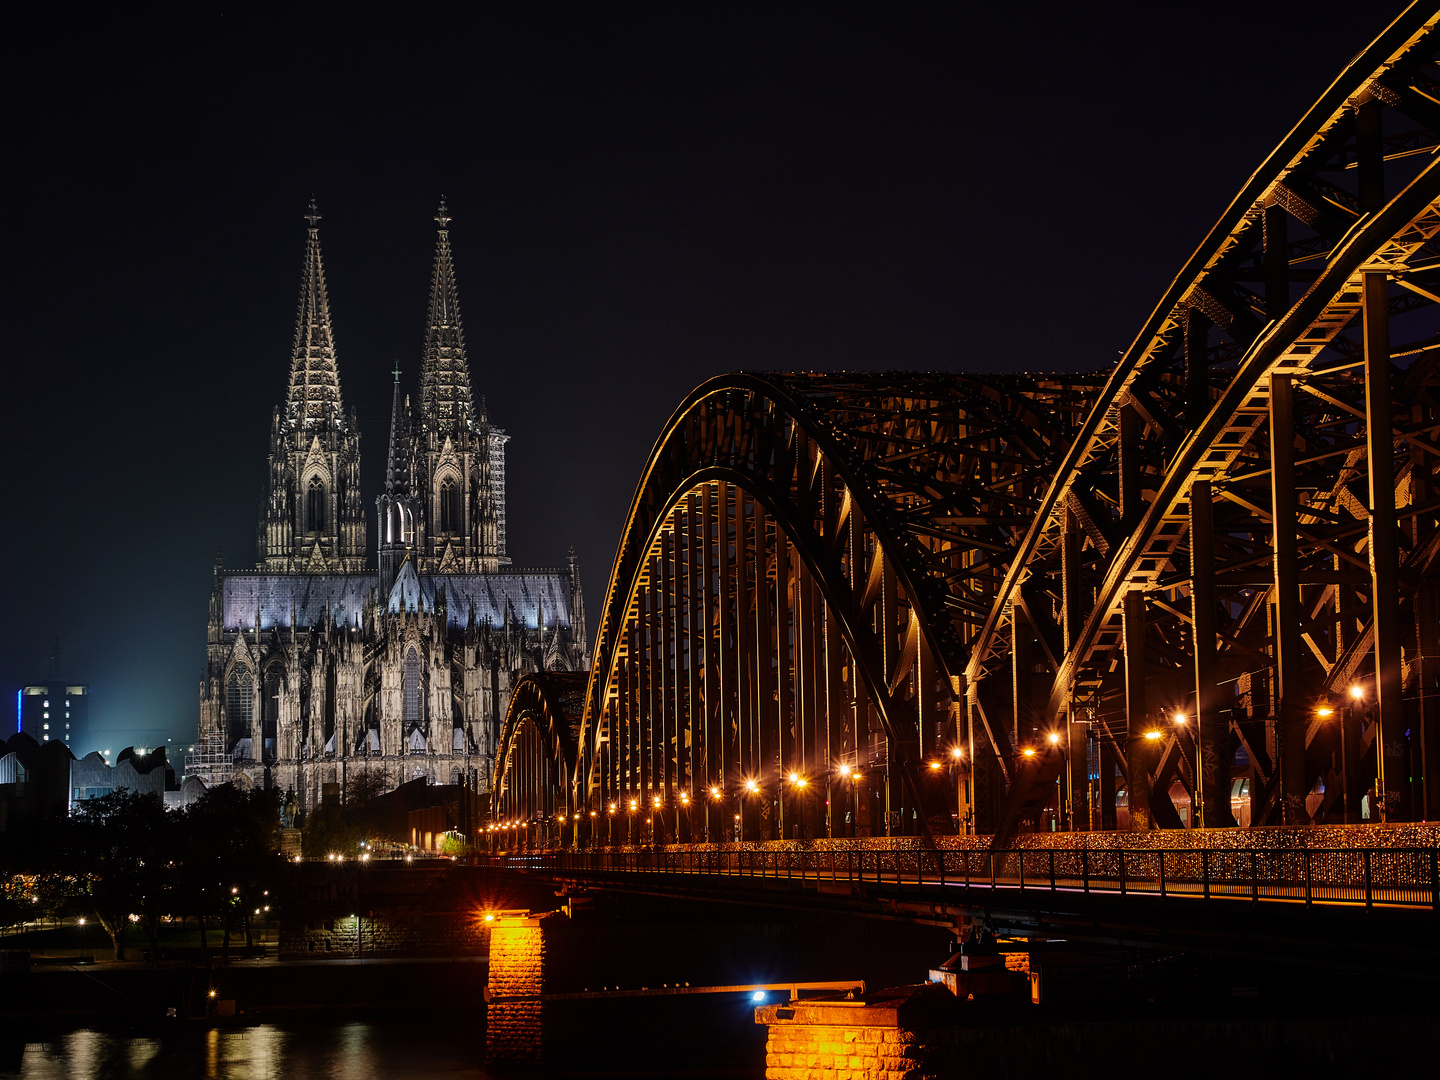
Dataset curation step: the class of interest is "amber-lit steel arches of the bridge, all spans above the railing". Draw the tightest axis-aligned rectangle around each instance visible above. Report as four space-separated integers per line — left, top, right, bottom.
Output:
497 4 1440 842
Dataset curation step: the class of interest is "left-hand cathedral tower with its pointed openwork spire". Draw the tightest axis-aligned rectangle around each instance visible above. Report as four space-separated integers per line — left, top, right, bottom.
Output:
258 199 364 573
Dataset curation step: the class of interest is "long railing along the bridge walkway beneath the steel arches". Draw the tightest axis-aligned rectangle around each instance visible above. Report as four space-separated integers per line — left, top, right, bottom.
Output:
492 847 1440 912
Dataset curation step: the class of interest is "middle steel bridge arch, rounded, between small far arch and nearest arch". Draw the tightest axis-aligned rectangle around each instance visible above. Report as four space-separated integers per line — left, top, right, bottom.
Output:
555 374 1099 838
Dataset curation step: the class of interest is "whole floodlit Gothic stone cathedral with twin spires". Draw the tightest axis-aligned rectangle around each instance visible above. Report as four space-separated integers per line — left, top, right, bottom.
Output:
187 202 589 809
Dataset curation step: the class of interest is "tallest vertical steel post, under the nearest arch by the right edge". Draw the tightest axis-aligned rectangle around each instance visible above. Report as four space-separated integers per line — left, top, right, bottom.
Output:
1364 271 1405 821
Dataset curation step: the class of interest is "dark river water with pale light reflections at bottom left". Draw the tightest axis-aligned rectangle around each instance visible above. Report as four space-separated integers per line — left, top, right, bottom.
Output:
0 1021 485 1080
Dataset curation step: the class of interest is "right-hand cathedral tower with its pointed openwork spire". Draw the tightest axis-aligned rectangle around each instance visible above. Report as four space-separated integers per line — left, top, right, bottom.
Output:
415 200 510 573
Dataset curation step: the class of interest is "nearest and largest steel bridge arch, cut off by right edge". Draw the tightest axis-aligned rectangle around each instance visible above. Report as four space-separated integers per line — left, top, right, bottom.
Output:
966 6 1440 841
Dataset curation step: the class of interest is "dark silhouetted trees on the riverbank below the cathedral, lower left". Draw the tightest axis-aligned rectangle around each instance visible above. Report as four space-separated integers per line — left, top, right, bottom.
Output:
0 785 282 960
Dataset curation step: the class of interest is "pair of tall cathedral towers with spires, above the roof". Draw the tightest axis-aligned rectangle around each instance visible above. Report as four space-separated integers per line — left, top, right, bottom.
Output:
259 202 510 588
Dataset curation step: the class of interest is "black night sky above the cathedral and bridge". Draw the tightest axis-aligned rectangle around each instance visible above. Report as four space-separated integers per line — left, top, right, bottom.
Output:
0 0 1400 752
